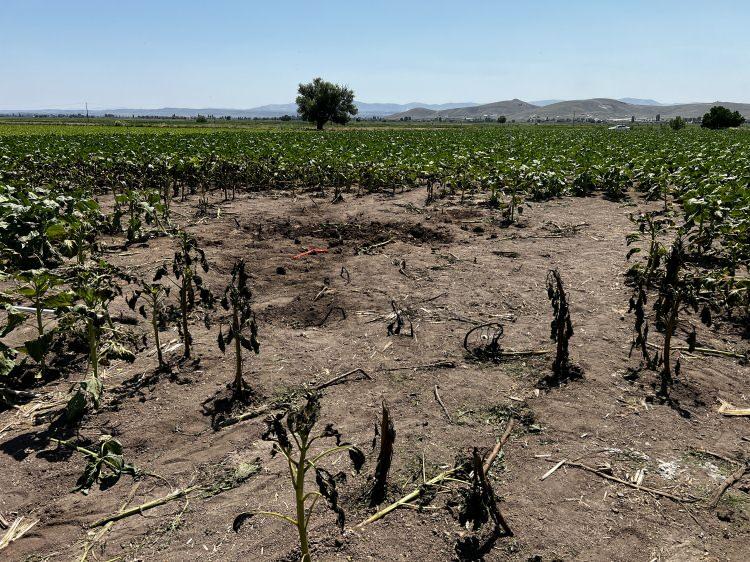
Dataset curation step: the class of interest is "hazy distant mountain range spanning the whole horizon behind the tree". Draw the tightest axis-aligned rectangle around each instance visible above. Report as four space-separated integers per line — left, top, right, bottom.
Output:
0 98 750 121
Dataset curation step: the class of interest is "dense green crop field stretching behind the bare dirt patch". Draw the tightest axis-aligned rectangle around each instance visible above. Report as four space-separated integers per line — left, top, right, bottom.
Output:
0 120 750 263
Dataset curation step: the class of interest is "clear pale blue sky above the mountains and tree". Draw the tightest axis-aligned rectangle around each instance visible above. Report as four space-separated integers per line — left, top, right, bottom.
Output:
0 0 750 109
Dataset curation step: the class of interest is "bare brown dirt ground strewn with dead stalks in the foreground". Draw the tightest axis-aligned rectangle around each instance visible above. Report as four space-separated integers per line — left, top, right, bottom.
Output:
0 191 750 561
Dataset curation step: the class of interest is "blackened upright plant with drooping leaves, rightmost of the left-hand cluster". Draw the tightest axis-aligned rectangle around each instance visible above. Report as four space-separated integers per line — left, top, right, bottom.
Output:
217 260 260 401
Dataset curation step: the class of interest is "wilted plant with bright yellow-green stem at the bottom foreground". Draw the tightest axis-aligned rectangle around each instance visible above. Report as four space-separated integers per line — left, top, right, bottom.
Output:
232 393 365 562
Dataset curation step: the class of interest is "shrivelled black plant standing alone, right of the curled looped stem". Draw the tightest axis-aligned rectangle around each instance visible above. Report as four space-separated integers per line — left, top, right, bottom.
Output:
543 269 583 386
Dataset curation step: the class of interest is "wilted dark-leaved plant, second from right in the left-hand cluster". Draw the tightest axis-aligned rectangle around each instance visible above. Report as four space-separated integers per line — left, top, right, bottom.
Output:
172 230 214 359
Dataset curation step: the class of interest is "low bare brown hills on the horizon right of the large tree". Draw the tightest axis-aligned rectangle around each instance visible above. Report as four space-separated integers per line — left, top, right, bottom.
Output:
386 98 750 121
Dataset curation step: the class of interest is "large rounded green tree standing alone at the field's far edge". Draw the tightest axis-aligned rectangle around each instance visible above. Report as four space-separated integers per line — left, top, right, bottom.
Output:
297 78 357 131
